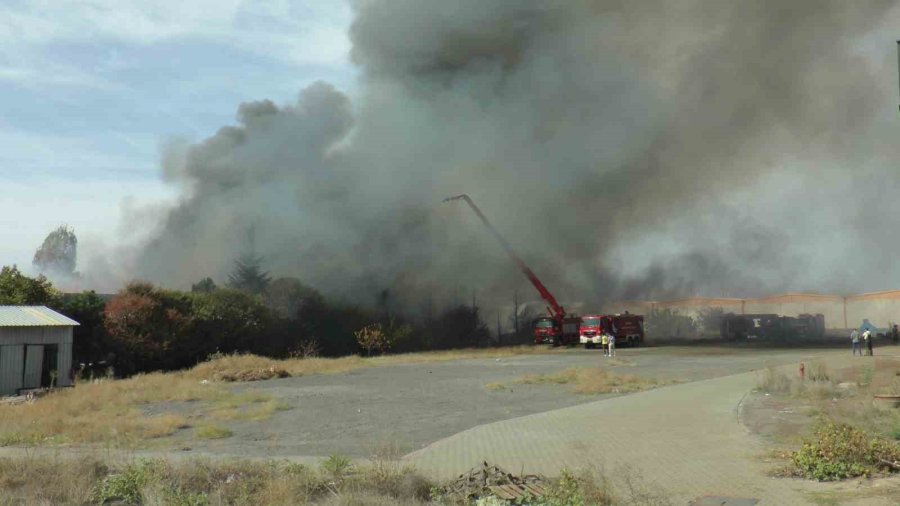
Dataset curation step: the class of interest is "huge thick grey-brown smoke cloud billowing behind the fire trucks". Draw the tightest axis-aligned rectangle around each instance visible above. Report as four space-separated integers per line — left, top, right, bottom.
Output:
123 0 900 314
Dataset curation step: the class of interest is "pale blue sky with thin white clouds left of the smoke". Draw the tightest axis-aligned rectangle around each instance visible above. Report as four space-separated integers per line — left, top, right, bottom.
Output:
0 0 354 268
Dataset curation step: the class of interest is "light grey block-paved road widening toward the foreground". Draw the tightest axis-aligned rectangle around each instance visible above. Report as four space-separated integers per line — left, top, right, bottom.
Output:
405 352 900 505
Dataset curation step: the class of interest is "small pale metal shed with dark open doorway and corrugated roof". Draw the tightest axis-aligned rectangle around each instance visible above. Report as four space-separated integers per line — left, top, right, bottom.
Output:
0 306 78 395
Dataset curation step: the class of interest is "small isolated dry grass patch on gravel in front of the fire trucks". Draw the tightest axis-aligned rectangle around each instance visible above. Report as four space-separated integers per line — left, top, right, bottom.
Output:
516 367 672 394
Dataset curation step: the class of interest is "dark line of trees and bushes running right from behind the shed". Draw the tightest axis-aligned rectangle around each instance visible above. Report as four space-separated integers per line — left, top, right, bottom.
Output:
0 266 491 376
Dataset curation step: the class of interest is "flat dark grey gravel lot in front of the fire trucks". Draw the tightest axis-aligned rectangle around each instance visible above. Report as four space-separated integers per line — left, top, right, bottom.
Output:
173 347 836 457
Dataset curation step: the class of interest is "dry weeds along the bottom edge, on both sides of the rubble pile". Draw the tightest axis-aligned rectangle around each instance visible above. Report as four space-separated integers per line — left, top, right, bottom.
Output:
0 456 671 506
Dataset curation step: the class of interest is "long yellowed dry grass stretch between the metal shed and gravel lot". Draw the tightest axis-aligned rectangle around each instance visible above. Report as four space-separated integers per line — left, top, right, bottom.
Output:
0 346 545 448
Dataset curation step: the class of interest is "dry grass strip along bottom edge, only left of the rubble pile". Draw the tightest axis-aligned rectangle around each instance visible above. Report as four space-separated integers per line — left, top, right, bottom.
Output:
0 452 434 506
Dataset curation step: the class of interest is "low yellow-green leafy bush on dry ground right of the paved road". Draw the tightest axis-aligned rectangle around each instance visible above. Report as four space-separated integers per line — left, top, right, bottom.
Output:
791 422 900 481
